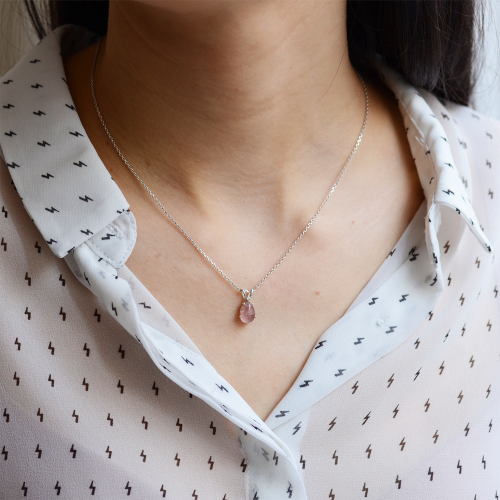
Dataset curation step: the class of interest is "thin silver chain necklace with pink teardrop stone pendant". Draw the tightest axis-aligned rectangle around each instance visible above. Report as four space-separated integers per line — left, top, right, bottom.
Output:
90 38 369 323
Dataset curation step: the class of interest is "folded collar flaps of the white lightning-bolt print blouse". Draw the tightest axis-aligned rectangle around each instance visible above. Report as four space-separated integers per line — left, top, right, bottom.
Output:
0 25 491 267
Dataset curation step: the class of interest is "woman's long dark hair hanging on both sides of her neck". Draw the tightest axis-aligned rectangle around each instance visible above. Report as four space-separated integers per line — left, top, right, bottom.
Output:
24 0 483 105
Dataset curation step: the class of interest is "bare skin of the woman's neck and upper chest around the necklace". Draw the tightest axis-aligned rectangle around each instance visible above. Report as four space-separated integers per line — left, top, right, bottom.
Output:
64 0 424 419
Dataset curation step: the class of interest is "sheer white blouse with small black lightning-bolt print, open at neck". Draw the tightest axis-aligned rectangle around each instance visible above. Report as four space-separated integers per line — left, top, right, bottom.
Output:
0 25 500 500
